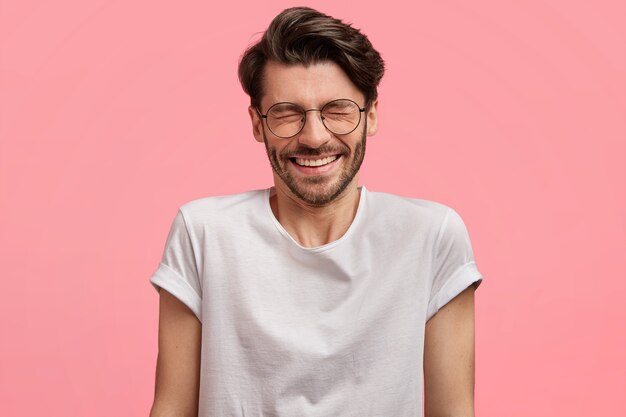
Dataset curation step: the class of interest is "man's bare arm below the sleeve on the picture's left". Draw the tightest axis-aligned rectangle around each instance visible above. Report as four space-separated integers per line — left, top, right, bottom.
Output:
150 288 202 417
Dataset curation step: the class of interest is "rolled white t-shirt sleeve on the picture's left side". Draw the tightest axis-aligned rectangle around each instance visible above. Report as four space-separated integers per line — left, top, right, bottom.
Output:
150 209 202 321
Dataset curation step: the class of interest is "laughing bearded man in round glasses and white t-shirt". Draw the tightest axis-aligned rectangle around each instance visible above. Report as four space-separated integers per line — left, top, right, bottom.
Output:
150 8 482 417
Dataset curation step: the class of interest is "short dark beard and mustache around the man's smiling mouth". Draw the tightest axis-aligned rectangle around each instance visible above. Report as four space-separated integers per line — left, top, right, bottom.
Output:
263 120 367 206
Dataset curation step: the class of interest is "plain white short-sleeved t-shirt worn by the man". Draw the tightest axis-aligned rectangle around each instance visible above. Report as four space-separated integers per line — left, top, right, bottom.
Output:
150 186 482 417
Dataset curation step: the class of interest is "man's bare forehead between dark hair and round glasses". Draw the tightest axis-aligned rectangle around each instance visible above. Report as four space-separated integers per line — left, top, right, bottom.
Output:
261 61 365 109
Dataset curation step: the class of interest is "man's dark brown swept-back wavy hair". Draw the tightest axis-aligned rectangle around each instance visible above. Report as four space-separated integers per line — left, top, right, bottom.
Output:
239 7 385 108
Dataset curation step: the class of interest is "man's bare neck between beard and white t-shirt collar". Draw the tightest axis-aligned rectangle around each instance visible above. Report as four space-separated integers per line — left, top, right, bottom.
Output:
270 177 361 248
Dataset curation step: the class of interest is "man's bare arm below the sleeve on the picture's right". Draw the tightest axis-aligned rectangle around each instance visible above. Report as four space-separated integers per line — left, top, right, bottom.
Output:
424 285 475 417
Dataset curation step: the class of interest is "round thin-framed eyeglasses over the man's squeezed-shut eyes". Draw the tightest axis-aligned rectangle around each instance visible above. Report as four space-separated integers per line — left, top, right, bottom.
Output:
257 98 365 139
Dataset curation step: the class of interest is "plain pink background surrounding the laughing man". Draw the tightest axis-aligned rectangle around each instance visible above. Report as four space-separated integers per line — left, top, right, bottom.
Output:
0 0 626 417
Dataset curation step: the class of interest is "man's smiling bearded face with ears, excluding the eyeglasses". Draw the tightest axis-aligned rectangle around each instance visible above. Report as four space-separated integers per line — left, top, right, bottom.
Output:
249 61 378 206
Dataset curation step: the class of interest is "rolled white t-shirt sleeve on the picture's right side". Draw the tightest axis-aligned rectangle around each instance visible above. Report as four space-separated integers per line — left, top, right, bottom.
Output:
426 207 483 321
